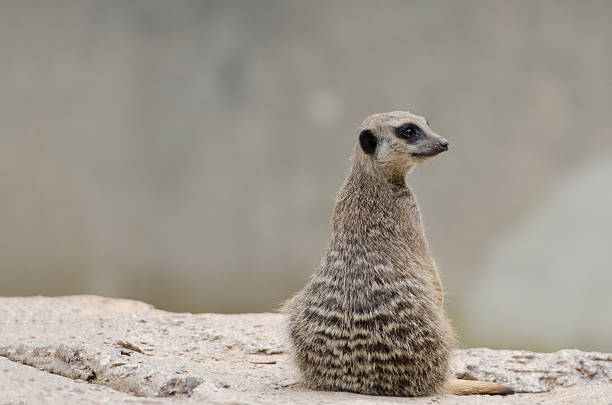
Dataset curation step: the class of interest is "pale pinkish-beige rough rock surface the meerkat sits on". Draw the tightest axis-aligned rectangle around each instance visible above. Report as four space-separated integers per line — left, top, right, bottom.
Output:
0 296 612 405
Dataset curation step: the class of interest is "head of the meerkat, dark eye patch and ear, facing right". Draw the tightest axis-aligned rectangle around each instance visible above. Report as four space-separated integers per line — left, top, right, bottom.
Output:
357 111 448 183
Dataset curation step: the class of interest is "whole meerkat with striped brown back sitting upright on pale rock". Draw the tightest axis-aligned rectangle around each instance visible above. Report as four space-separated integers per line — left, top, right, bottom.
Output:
283 111 513 396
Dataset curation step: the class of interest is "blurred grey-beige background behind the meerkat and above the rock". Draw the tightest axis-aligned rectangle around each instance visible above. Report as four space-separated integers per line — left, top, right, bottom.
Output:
0 0 612 351
